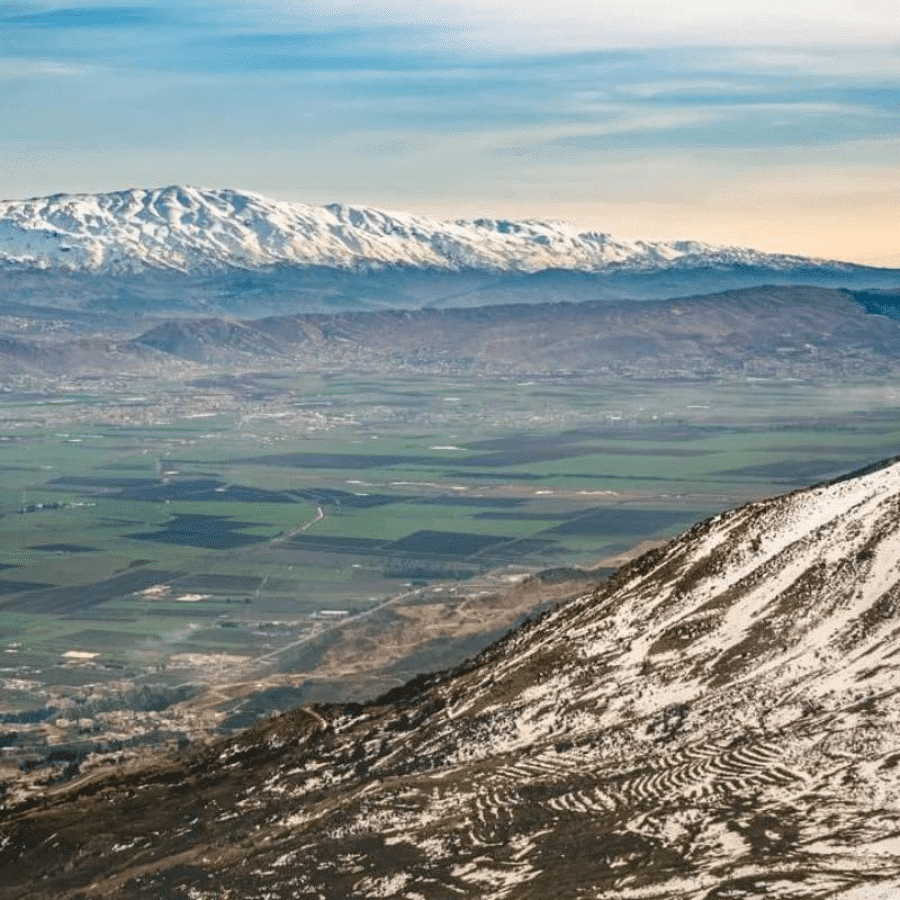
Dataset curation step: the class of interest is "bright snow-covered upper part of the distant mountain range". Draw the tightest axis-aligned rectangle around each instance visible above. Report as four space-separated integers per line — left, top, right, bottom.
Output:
0 186 852 274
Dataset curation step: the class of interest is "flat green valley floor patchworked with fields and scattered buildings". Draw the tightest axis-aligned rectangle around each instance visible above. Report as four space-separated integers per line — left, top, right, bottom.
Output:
0 372 900 772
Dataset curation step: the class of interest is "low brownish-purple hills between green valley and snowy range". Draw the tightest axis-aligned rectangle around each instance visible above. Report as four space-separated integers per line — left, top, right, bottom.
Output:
0 287 900 378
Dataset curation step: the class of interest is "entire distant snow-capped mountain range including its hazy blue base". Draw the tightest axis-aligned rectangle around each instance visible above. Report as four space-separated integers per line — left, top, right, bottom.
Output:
0 187 900 313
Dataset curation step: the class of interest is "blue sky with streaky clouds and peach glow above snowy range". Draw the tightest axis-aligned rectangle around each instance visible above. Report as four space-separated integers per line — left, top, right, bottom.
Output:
0 0 900 267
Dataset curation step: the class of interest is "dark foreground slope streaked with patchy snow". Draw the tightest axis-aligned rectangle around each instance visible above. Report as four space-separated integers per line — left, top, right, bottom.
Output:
0 461 900 900
